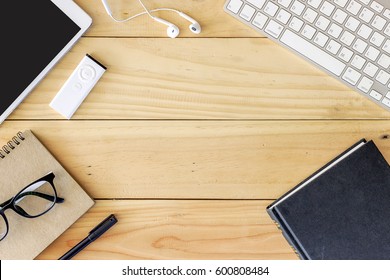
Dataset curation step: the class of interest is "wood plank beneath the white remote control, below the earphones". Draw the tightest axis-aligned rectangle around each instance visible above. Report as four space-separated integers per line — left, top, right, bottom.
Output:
10 38 390 119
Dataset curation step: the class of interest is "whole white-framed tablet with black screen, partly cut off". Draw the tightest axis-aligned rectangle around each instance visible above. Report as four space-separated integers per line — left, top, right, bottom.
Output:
0 0 92 123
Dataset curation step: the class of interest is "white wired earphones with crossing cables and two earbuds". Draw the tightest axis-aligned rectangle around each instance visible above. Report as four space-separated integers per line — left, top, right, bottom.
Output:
102 0 202 38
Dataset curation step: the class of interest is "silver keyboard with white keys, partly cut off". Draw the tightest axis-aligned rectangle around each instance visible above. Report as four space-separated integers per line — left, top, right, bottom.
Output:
224 0 390 111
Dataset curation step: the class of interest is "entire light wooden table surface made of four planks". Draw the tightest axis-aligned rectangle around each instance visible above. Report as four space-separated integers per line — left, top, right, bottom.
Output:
4 0 390 259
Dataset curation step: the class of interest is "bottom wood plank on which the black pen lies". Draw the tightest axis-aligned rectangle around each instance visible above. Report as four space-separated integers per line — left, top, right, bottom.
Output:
38 200 297 260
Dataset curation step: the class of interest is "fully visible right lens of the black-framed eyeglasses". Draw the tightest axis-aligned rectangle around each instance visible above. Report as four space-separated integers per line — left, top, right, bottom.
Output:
14 181 55 216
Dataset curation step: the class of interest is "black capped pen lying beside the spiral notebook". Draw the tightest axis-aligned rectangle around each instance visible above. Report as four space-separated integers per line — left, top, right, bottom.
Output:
59 214 118 260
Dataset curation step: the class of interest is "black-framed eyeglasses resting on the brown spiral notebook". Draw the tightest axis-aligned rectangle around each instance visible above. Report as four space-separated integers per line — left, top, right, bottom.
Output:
0 172 64 241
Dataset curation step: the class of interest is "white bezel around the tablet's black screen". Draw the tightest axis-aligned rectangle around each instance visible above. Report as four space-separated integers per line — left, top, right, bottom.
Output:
0 0 92 124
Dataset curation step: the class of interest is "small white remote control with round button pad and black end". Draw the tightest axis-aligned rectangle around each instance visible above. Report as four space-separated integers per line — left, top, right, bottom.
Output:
50 54 107 120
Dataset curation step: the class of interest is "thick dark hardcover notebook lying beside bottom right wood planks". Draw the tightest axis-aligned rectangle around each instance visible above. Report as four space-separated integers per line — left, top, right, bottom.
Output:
267 139 390 260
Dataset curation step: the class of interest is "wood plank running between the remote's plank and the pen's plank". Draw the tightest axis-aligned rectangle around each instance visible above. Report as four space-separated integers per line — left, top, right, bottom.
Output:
0 121 390 199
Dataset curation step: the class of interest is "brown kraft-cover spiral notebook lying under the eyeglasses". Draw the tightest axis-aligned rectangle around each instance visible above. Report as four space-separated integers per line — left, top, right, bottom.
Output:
0 130 94 260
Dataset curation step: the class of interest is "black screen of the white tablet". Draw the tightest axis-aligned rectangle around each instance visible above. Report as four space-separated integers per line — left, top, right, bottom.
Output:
0 0 80 115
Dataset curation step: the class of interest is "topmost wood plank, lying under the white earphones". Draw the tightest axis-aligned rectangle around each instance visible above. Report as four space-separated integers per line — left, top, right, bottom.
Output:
75 0 262 40
